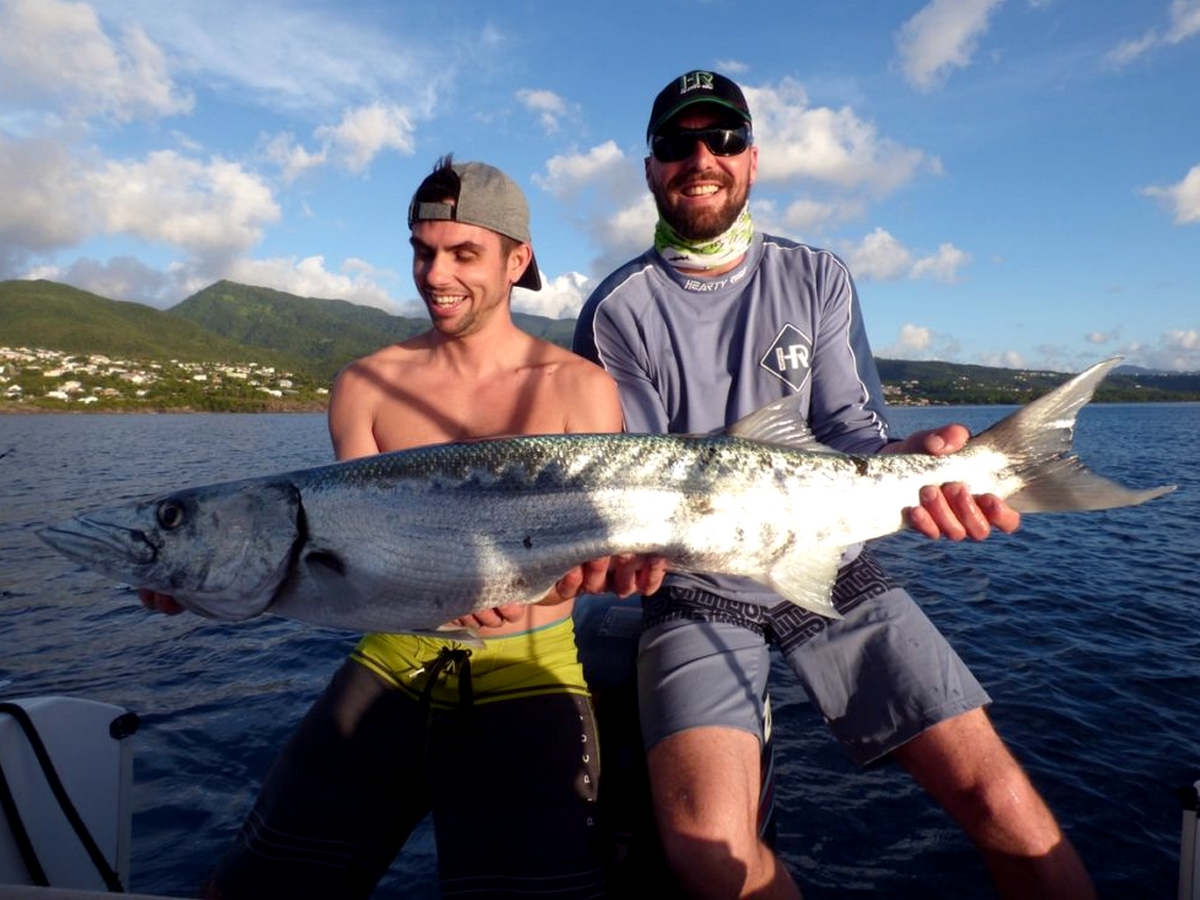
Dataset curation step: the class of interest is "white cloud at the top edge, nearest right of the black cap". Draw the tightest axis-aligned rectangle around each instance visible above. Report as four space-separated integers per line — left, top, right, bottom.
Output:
895 0 1003 90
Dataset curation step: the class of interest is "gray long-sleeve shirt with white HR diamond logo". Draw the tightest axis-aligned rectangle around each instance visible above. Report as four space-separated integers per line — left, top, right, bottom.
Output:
575 233 888 604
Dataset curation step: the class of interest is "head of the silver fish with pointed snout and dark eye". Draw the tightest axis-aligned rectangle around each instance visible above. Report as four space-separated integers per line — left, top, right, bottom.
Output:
40 479 302 620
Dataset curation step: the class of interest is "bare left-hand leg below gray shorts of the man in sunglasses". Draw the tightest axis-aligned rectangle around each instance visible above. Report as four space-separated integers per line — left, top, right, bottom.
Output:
647 726 800 900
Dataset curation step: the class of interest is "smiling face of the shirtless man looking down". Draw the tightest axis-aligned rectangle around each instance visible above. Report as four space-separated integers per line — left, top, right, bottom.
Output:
409 220 532 336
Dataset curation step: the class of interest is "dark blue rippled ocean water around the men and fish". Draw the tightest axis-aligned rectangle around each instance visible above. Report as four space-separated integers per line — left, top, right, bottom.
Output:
0 404 1200 900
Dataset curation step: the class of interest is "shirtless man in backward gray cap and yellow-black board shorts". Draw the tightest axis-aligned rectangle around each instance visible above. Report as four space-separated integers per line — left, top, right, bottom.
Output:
143 157 662 900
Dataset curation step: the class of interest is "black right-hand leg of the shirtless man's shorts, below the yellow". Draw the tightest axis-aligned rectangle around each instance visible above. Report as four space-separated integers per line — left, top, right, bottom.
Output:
428 696 607 900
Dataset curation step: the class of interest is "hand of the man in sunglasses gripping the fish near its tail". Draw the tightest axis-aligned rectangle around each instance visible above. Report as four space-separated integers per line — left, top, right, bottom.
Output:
880 422 1021 541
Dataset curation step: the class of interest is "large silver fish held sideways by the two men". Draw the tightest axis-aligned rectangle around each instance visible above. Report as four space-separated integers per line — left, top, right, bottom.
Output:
41 359 1174 636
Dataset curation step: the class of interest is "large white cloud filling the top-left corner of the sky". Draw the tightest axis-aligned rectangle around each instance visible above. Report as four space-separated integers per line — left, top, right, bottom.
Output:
0 0 192 121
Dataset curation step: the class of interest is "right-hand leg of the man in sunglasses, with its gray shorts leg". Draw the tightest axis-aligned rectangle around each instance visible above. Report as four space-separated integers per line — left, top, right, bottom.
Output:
768 551 1094 898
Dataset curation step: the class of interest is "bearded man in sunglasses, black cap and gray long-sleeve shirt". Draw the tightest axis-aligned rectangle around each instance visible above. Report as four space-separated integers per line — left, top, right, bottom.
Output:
575 72 1094 900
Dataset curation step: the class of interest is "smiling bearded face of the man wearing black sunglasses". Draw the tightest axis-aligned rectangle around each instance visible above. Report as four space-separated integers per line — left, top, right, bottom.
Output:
646 106 758 241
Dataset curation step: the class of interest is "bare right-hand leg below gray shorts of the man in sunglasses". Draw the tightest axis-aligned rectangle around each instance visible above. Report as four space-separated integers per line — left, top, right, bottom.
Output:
894 709 1096 900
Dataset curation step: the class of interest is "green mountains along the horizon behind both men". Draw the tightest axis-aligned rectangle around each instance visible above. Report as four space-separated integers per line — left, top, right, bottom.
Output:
0 281 1200 403
